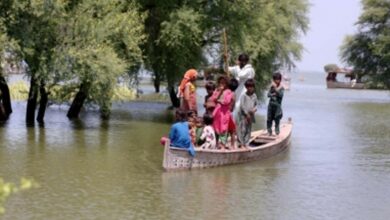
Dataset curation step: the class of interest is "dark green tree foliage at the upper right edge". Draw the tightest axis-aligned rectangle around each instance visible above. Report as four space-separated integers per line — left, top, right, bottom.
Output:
341 0 390 88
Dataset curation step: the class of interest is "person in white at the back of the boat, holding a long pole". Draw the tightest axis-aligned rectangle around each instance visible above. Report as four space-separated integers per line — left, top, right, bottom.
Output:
229 53 255 120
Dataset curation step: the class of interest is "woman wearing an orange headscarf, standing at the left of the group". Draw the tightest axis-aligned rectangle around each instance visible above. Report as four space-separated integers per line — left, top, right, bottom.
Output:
179 69 198 112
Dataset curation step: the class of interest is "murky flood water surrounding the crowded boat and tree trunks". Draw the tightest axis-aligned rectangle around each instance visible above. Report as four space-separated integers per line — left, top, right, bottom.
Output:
0 74 390 219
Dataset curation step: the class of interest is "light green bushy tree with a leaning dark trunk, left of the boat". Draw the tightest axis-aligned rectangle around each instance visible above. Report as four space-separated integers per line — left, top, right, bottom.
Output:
57 0 144 118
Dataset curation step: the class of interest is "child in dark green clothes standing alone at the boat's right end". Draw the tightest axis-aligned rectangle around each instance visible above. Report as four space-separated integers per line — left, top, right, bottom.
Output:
267 72 284 135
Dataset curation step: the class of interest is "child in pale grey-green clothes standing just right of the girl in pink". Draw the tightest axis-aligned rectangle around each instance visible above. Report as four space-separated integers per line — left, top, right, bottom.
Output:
237 79 257 148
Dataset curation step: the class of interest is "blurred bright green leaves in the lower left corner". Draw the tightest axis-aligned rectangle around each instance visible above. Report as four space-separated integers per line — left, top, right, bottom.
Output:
0 178 39 214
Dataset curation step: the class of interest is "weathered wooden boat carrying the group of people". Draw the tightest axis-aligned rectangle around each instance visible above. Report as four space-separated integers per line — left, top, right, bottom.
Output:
163 120 292 171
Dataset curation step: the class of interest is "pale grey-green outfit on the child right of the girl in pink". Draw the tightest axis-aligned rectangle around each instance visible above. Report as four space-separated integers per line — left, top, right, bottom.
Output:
237 93 258 145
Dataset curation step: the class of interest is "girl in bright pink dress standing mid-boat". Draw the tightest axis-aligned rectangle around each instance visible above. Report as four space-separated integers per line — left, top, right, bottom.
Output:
210 76 234 149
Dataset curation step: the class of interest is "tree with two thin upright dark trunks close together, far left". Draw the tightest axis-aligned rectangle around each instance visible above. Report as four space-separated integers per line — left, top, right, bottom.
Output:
0 0 69 123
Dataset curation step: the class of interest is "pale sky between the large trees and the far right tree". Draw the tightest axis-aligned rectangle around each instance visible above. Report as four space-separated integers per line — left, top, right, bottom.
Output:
296 0 361 71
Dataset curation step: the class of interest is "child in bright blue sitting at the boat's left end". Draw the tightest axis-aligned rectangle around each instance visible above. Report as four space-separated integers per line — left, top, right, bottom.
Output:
169 110 195 156
